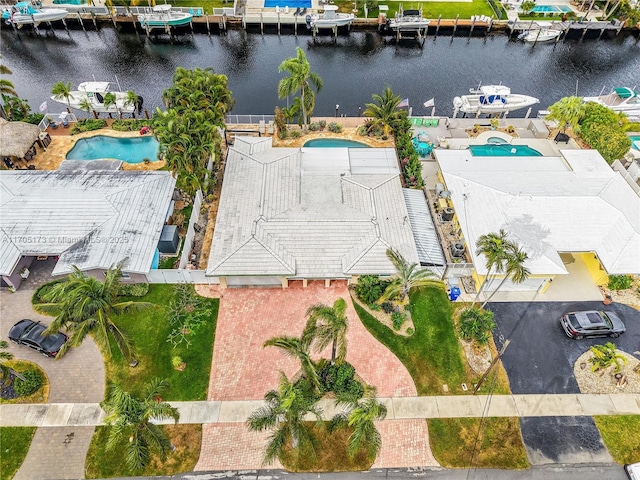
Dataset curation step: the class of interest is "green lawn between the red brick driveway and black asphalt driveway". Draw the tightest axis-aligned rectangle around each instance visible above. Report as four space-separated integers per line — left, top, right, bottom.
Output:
354 288 469 395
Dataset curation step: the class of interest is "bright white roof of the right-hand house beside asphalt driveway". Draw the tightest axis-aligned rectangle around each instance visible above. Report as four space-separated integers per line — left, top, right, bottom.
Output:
436 150 640 275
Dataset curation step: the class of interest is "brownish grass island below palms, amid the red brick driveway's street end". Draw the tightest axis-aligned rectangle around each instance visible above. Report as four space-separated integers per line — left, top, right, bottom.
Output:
282 422 375 472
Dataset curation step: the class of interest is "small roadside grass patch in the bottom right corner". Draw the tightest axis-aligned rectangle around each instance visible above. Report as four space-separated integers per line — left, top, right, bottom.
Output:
593 415 640 464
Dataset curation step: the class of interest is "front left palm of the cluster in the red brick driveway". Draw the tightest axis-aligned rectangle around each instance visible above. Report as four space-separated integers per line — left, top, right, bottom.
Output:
247 372 322 465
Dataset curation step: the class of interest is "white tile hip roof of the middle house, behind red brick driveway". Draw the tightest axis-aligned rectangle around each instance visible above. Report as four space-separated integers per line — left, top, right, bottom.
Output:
207 137 418 278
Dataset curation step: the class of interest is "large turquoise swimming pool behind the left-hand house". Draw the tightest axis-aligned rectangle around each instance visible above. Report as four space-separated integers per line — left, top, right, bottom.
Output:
67 135 160 163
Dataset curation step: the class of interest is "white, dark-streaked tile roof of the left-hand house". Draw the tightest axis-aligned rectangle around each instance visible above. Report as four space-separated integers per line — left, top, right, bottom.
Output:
0 170 175 275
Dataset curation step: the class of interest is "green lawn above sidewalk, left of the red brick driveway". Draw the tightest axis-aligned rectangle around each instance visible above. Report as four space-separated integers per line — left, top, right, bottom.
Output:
106 284 219 401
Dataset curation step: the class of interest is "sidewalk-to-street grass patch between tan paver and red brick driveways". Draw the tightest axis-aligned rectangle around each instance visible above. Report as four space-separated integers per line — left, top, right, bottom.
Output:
85 424 202 478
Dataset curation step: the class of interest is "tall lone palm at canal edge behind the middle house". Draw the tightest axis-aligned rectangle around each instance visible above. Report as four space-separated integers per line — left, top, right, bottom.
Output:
278 47 322 130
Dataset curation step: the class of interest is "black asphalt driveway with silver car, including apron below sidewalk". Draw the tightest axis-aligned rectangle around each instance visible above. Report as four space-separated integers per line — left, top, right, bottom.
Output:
490 302 640 465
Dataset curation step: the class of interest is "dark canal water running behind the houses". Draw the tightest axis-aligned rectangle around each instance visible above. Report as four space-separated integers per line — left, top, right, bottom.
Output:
0 26 640 117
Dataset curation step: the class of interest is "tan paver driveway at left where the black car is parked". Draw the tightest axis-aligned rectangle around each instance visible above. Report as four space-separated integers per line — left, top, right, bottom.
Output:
0 289 105 480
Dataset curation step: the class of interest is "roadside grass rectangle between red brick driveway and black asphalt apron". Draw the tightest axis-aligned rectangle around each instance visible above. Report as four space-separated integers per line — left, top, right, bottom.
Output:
427 418 529 469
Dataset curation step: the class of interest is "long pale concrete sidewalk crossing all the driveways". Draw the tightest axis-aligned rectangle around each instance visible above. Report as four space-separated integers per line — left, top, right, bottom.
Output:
0 394 640 427
